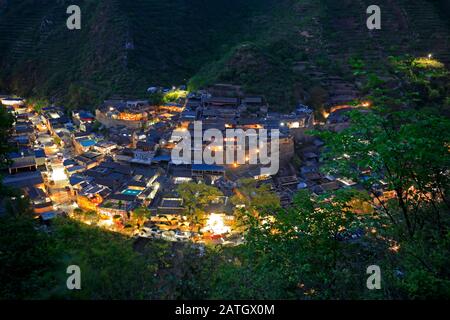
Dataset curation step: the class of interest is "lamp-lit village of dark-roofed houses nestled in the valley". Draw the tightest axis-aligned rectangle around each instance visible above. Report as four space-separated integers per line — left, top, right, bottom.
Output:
0 84 378 245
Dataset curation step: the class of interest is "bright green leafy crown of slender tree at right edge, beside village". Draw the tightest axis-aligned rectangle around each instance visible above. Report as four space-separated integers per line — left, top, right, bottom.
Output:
319 111 450 235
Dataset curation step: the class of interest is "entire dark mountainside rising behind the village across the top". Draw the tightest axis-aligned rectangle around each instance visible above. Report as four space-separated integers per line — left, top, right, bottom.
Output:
0 0 450 109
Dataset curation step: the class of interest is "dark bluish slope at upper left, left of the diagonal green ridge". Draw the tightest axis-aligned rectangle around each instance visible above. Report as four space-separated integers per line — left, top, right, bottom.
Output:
0 0 276 103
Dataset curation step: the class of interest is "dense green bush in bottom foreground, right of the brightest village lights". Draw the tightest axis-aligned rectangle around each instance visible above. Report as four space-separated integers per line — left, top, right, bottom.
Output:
213 192 376 299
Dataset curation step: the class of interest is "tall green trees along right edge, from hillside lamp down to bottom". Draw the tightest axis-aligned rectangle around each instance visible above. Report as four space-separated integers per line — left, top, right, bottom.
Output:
304 58 450 299
